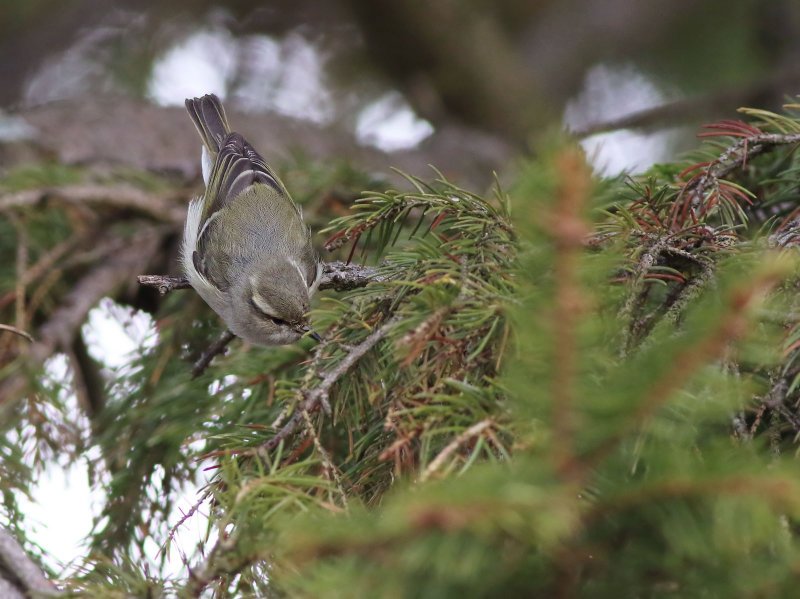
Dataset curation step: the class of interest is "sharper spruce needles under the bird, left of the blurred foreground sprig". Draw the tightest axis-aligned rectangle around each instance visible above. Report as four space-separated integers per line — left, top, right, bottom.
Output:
59 166 516 595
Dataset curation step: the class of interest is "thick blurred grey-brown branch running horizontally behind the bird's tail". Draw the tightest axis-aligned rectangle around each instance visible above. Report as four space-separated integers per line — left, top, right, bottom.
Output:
15 96 513 190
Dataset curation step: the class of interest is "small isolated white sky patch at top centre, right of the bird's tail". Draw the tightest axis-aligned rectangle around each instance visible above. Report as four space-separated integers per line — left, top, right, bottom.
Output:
356 92 433 152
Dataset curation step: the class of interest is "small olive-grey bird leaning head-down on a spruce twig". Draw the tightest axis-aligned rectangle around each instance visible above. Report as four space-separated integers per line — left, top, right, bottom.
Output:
181 94 322 345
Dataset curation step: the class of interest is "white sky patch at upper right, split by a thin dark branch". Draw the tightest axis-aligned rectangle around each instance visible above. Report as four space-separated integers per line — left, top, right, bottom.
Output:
564 65 679 175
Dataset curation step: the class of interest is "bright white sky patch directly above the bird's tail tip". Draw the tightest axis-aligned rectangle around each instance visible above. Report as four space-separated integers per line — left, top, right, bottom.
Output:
147 30 238 106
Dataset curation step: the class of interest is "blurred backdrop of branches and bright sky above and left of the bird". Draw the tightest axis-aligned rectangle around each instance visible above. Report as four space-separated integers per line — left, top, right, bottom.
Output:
0 0 800 580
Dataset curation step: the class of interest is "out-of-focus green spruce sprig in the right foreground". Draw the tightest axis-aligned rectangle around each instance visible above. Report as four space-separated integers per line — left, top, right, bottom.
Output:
260 139 800 597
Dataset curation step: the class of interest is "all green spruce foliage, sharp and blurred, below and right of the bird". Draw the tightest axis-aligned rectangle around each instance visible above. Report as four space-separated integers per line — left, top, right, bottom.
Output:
14 106 800 598
